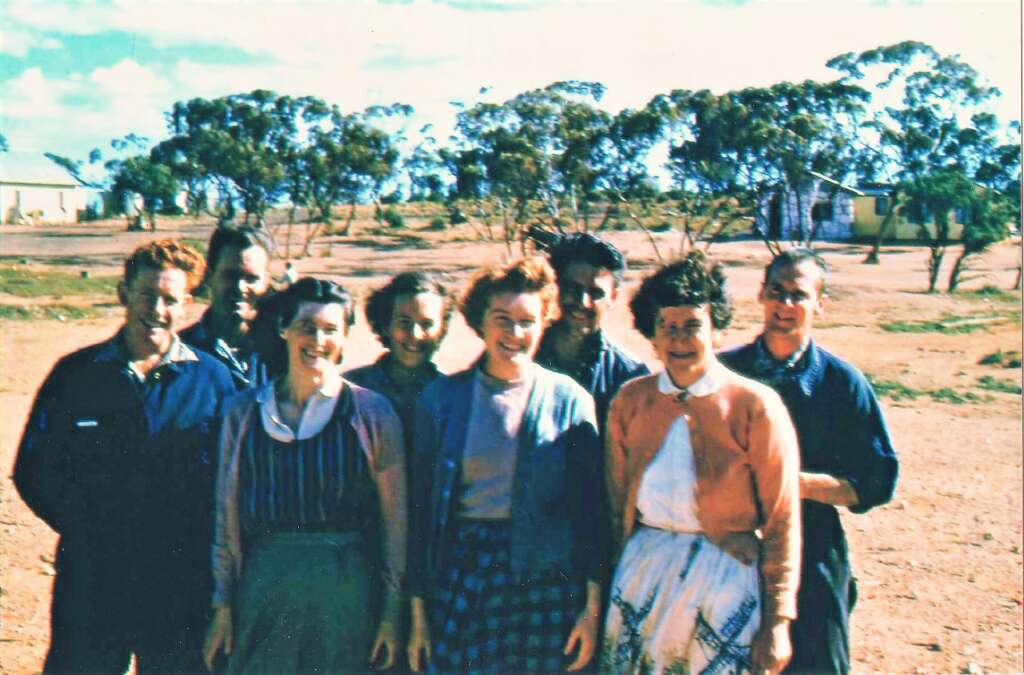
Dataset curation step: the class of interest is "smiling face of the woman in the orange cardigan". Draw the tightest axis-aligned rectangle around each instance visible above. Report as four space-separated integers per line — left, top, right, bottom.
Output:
650 304 715 387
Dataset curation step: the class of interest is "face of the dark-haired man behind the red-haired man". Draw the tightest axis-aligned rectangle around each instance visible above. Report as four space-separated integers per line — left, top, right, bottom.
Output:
207 246 270 342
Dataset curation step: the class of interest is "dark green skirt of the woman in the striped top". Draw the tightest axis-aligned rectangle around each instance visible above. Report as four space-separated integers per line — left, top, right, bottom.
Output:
227 533 380 675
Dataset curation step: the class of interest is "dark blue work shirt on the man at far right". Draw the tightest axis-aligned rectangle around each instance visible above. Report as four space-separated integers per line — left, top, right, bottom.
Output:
719 344 899 588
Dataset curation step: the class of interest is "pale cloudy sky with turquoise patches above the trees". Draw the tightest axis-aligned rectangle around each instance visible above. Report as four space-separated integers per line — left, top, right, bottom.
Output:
0 0 1021 173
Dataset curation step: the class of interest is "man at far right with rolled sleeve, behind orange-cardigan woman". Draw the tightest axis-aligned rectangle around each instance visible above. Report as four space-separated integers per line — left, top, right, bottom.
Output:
720 249 899 673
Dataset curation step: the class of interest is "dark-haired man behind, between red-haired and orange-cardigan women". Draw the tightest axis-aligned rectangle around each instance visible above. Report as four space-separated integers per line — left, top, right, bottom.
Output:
535 233 649 430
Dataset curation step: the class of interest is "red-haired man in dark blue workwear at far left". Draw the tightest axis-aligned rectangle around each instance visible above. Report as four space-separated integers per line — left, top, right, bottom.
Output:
13 240 234 673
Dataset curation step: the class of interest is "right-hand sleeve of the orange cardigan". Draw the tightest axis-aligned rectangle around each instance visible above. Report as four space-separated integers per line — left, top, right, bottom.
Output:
749 391 801 619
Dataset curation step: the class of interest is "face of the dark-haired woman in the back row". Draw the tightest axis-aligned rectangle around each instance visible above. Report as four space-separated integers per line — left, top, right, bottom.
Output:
387 293 444 370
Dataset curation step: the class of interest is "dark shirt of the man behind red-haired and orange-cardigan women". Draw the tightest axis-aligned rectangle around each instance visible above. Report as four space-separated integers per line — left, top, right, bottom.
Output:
534 331 650 437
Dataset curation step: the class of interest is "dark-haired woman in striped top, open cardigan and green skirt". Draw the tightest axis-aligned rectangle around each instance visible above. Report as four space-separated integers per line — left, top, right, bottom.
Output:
205 278 407 673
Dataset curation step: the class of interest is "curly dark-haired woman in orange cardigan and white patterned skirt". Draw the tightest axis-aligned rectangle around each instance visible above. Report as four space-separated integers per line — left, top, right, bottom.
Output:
601 253 800 673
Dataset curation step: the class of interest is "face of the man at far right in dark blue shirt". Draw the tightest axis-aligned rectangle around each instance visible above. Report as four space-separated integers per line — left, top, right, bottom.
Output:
758 260 824 358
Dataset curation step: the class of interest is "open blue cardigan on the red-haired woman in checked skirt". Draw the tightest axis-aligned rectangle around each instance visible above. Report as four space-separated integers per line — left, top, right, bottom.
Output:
409 366 610 595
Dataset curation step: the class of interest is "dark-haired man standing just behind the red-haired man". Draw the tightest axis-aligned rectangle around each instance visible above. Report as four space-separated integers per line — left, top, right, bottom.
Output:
181 227 271 389
